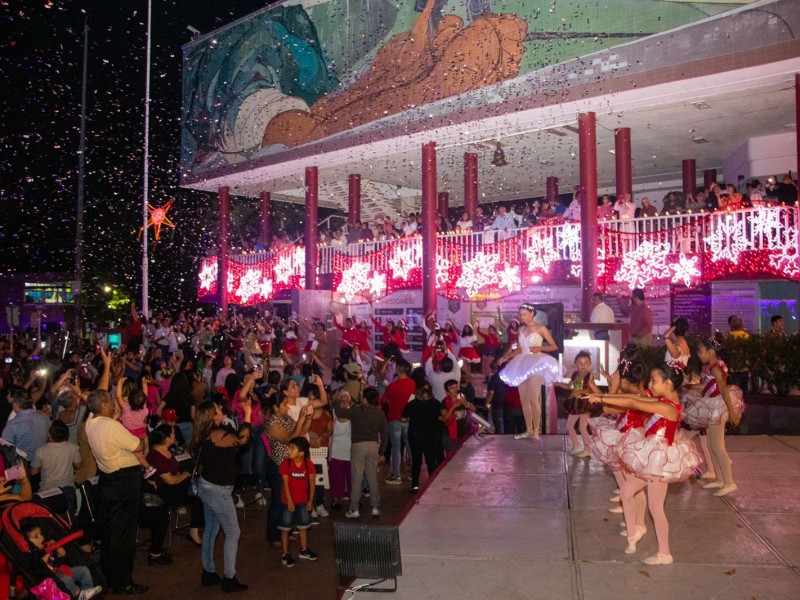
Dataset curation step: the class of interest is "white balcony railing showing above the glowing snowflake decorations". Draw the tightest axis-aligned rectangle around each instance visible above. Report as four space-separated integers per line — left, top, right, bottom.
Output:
225 206 800 275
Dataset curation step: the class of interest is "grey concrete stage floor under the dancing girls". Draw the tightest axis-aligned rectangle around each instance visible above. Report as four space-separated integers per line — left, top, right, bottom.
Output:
354 435 800 600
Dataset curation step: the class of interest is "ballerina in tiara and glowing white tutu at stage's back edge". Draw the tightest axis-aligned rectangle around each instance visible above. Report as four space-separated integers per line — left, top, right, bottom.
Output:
497 303 561 440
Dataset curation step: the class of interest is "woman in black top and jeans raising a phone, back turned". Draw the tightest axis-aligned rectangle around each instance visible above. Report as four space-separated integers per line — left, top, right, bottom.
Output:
191 398 253 592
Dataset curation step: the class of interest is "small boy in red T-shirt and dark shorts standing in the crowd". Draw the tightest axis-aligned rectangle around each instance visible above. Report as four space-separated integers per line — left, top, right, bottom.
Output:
278 437 317 567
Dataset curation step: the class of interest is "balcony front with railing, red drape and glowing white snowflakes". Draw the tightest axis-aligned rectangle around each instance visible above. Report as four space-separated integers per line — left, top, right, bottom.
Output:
198 206 800 305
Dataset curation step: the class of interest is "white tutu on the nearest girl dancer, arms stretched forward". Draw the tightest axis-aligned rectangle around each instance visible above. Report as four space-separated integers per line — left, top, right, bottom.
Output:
617 428 703 483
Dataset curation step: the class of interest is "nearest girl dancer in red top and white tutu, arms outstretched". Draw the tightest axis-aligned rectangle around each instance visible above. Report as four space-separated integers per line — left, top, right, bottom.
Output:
589 362 700 565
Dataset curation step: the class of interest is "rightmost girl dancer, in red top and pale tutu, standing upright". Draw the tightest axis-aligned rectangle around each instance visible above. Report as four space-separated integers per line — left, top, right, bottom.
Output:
683 337 744 496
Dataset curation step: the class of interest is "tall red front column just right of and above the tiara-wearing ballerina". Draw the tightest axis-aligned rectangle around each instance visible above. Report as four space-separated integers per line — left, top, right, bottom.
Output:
578 112 596 321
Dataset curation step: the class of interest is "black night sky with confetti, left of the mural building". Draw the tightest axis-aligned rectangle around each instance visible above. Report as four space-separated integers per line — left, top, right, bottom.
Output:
0 0 294 308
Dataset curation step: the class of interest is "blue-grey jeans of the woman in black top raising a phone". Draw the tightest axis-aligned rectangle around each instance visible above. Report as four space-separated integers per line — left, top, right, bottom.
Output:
198 477 240 579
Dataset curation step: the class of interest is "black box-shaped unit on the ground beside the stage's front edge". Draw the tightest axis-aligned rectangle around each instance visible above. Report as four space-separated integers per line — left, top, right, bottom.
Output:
333 522 403 592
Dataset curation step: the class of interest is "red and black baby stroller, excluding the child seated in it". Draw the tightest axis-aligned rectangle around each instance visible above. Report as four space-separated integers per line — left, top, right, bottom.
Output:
0 502 106 597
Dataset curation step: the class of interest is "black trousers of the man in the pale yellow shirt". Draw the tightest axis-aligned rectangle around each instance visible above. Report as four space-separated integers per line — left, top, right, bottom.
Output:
98 465 142 589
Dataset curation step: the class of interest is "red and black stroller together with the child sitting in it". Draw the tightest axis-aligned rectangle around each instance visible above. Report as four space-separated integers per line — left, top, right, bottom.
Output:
0 502 105 600
